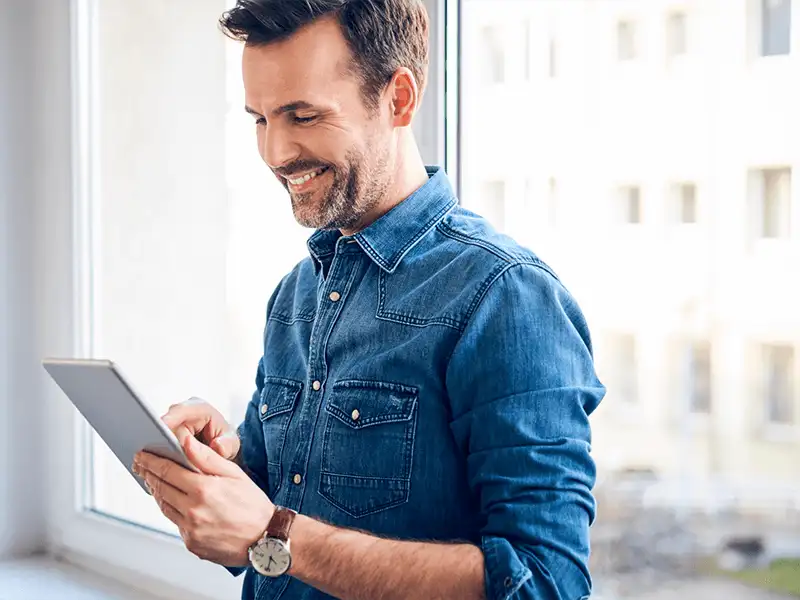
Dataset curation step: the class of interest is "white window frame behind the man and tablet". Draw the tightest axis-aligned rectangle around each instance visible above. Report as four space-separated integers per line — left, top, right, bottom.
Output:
38 0 450 600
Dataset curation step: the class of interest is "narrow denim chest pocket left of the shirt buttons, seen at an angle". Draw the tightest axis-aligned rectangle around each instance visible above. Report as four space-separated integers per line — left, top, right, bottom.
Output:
258 377 303 498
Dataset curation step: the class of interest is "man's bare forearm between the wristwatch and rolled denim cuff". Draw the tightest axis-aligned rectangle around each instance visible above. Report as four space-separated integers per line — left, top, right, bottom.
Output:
289 515 484 600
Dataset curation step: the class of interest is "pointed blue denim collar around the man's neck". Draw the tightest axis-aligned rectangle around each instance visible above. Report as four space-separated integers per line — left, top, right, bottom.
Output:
307 166 457 273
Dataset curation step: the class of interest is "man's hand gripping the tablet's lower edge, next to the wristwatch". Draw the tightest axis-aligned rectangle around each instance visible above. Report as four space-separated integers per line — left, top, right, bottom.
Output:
133 436 275 567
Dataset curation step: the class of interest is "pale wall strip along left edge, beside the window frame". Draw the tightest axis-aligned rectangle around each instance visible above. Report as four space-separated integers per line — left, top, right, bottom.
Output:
0 0 46 558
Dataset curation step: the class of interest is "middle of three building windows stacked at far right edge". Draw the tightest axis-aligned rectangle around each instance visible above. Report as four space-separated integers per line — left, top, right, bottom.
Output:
753 168 792 239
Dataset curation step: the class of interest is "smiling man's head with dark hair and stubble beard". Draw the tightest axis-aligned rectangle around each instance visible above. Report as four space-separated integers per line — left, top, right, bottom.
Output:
220 0 428 230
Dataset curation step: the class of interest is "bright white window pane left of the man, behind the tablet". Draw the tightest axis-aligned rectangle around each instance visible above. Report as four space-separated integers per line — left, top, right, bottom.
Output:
73 0 309 548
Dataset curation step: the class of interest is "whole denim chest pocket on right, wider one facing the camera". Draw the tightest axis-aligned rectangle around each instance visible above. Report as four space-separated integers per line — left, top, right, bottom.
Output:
319 380 418 518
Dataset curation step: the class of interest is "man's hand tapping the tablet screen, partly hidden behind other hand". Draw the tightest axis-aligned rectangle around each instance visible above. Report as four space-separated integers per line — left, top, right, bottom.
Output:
161 398 241 460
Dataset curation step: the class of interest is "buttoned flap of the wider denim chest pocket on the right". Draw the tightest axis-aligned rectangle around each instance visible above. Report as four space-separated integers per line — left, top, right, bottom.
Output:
325 380 417 429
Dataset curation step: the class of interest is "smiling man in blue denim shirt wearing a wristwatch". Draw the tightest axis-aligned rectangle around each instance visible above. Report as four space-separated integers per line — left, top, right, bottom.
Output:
136 0 604 600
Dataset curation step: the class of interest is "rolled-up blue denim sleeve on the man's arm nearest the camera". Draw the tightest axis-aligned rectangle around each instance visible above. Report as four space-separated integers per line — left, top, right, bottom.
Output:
447 264 605 600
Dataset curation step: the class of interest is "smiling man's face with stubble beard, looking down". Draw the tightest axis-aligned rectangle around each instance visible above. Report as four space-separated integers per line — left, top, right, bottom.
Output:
242 19 392 230
